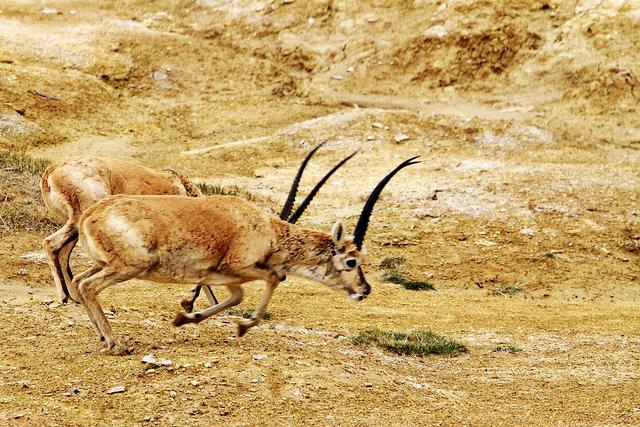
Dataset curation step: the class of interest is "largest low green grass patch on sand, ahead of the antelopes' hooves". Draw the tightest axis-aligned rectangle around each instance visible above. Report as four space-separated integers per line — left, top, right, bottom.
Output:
351 329 469 356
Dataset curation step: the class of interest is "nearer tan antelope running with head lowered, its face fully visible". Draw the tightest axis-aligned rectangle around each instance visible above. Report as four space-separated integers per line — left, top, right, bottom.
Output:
73 156 419 355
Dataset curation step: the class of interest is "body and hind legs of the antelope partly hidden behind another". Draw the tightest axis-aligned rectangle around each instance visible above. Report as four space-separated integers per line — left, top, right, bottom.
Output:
40 156 200 303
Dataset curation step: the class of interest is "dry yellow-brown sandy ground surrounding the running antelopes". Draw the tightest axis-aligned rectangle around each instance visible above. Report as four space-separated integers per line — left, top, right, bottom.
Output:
0 0 640 426
